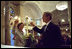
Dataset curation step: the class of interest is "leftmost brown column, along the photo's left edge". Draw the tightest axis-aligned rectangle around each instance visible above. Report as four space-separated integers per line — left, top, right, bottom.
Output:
1 1 5 44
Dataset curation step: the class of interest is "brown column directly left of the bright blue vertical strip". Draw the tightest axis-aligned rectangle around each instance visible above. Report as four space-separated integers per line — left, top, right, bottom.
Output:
5 1 10 45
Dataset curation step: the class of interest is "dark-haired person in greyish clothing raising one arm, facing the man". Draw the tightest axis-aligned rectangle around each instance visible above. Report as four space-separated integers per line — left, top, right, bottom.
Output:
12 20 25 46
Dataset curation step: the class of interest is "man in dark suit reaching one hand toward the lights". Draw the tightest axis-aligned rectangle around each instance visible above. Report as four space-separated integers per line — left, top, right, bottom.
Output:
30 12 62 48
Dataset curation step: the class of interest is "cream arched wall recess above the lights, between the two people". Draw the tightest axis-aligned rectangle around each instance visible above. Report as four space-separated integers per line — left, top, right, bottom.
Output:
20 2 42 25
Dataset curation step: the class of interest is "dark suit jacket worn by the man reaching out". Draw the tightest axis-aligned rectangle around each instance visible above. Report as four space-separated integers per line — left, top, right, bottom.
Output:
33 22 62 48
